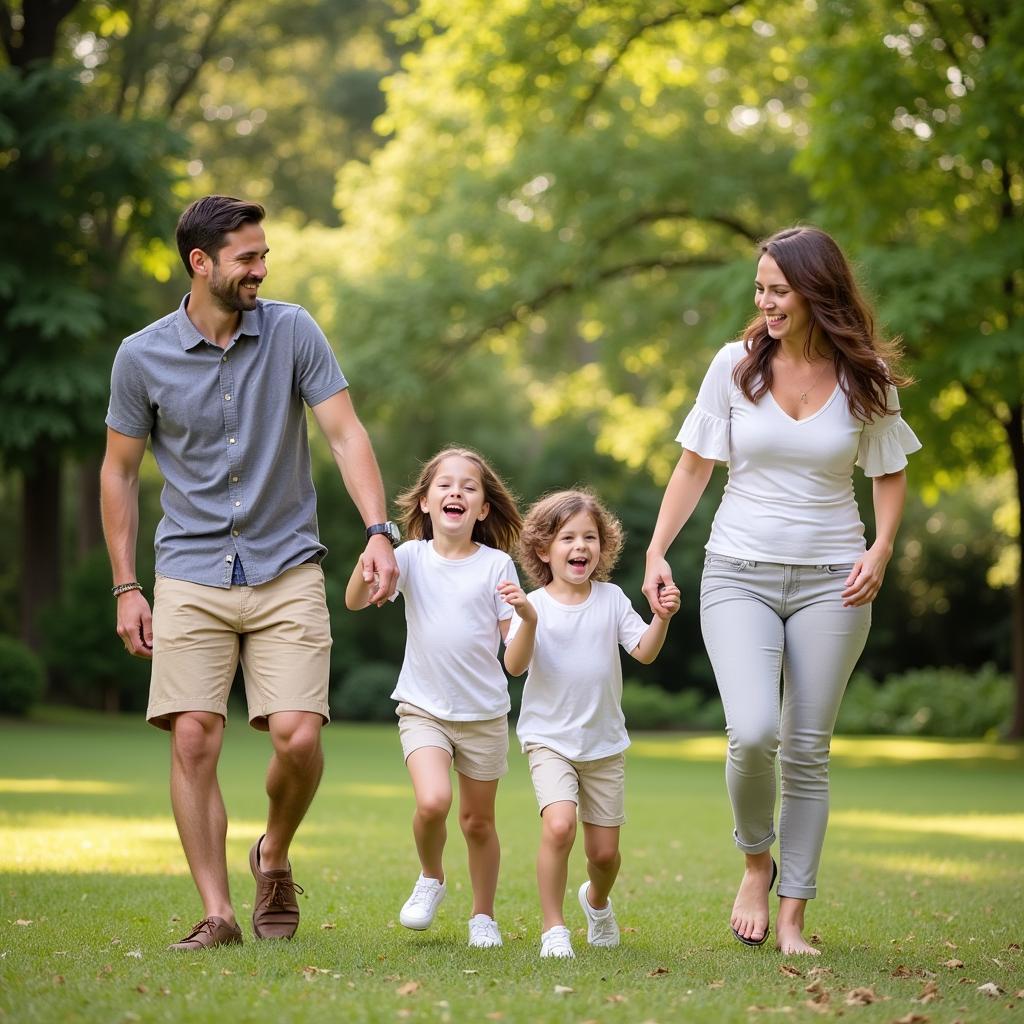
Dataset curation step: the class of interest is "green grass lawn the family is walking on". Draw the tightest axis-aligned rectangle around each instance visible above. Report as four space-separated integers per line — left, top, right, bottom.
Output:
0 712 1024 1024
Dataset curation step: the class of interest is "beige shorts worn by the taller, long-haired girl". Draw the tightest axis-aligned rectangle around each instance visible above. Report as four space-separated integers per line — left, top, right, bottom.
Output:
395 700 509 782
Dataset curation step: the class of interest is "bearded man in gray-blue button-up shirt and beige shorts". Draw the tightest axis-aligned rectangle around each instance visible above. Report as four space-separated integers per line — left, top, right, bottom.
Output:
100 196 397 950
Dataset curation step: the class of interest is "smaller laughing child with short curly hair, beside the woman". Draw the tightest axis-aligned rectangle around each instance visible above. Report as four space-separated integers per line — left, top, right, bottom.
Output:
499 490 679 957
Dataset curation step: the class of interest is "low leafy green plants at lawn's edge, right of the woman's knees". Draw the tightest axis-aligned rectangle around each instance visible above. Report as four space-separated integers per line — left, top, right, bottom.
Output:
836 666 1014 736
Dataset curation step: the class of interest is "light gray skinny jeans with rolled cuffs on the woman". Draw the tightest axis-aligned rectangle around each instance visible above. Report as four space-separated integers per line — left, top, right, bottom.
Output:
700 555 871 899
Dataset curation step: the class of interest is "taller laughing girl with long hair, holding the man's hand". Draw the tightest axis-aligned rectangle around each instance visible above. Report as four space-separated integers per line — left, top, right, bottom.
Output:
345 449 522 948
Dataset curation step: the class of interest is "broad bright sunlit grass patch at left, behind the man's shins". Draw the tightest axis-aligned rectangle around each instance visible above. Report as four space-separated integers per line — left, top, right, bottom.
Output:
0 813 264 874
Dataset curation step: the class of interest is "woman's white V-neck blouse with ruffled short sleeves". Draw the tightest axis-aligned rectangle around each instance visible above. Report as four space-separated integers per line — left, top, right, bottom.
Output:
676 341 921 565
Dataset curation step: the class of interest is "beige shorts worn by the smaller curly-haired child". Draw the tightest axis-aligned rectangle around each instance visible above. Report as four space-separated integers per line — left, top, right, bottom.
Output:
526 743 626 828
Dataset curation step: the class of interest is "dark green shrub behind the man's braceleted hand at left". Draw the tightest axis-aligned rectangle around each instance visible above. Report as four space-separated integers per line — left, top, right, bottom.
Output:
42 548 153 711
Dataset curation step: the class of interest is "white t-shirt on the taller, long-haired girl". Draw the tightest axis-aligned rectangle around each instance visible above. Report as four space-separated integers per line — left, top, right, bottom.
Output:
391 541 519 722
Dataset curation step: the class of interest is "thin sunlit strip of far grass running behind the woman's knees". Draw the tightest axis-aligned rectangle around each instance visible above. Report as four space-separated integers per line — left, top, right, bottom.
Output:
629 734 1024 768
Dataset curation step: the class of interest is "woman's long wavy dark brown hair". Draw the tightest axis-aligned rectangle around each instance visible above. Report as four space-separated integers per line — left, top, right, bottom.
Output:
734 227 912 422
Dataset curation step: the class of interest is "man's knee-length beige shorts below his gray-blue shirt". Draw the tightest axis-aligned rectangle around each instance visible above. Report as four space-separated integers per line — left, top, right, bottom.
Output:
145 562 331 730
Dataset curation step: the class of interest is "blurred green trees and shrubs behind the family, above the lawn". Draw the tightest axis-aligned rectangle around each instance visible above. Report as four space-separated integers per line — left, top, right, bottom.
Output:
0 0 1024 737
